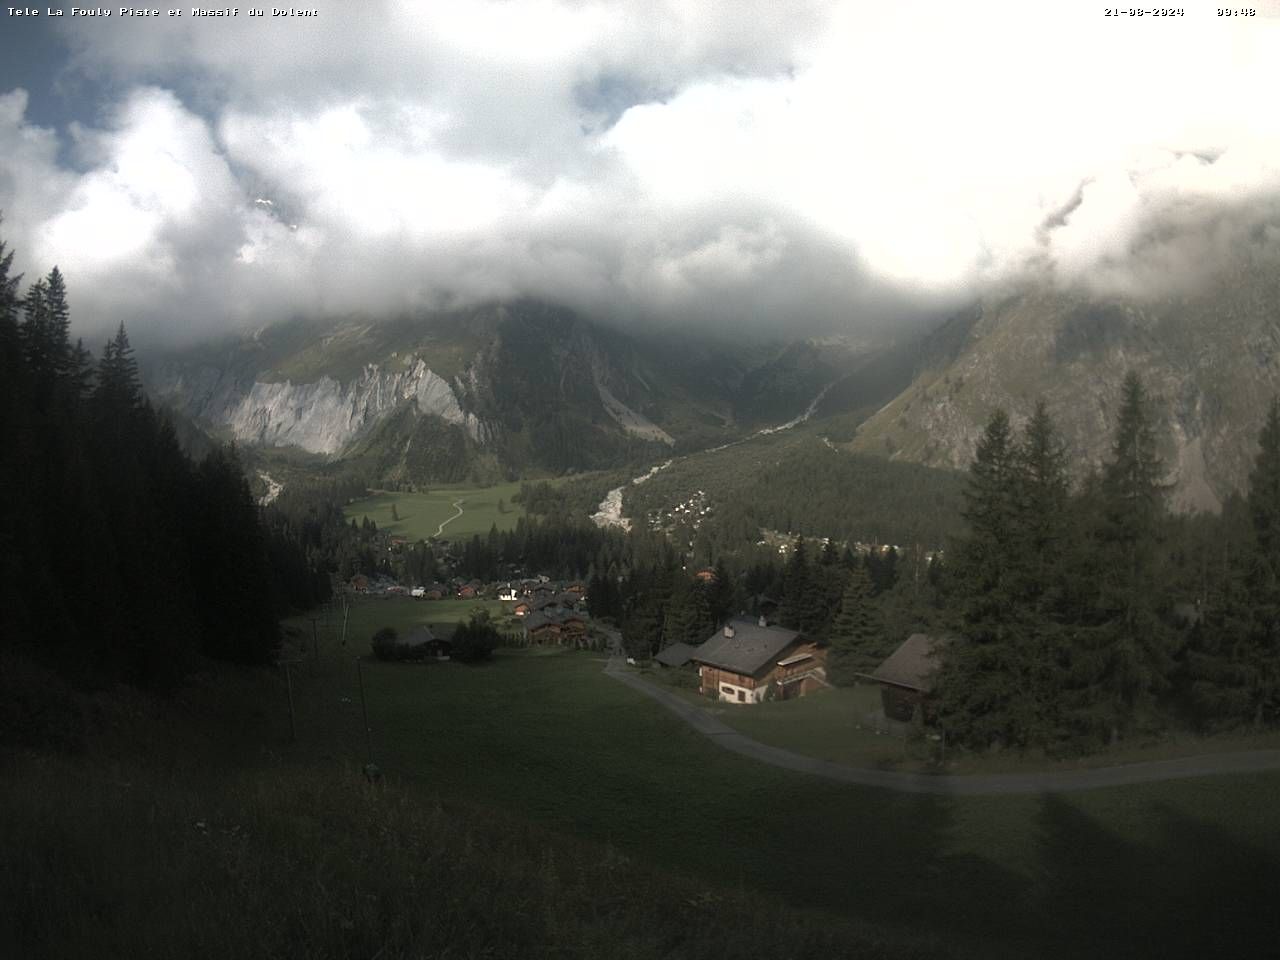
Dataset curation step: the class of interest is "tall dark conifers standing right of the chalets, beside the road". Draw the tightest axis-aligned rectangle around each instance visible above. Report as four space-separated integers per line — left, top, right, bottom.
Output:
921 374 1280 751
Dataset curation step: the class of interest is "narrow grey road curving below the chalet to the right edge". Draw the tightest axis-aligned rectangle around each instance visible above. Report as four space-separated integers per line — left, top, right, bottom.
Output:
604 647 1280 796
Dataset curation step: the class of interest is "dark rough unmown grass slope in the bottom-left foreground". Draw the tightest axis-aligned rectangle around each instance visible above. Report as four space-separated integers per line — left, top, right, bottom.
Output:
0 678 947 960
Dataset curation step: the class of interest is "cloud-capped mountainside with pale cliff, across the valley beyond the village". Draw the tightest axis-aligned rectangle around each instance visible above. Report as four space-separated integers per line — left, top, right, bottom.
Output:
146 301 887 484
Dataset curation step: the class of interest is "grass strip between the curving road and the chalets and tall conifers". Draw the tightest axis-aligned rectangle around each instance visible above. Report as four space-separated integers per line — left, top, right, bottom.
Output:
645 671 1280 774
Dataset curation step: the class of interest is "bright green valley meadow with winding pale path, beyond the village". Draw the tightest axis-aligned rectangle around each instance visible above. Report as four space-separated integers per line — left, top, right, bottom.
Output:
346 483 525 540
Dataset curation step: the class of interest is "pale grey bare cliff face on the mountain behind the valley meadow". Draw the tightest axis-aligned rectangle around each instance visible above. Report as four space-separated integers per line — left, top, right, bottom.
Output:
152 357 486 456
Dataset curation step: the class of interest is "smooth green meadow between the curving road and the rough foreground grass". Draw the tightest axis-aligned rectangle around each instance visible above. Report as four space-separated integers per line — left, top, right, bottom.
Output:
275 632 1280 956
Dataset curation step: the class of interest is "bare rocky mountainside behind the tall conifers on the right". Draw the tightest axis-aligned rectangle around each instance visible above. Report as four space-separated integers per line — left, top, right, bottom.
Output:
849 256 1280 509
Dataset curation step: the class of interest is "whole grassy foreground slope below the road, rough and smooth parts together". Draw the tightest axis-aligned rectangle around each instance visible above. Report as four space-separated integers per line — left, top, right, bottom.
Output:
0 649 1280 957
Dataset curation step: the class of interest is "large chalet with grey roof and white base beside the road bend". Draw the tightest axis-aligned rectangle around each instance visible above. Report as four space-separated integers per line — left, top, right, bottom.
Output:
690 617 827 703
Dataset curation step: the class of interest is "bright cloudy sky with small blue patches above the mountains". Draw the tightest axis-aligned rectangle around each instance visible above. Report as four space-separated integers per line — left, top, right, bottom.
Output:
0 0 1280 340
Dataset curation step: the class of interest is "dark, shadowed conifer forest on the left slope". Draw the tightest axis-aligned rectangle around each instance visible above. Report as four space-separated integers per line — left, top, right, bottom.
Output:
0 235 328 735
